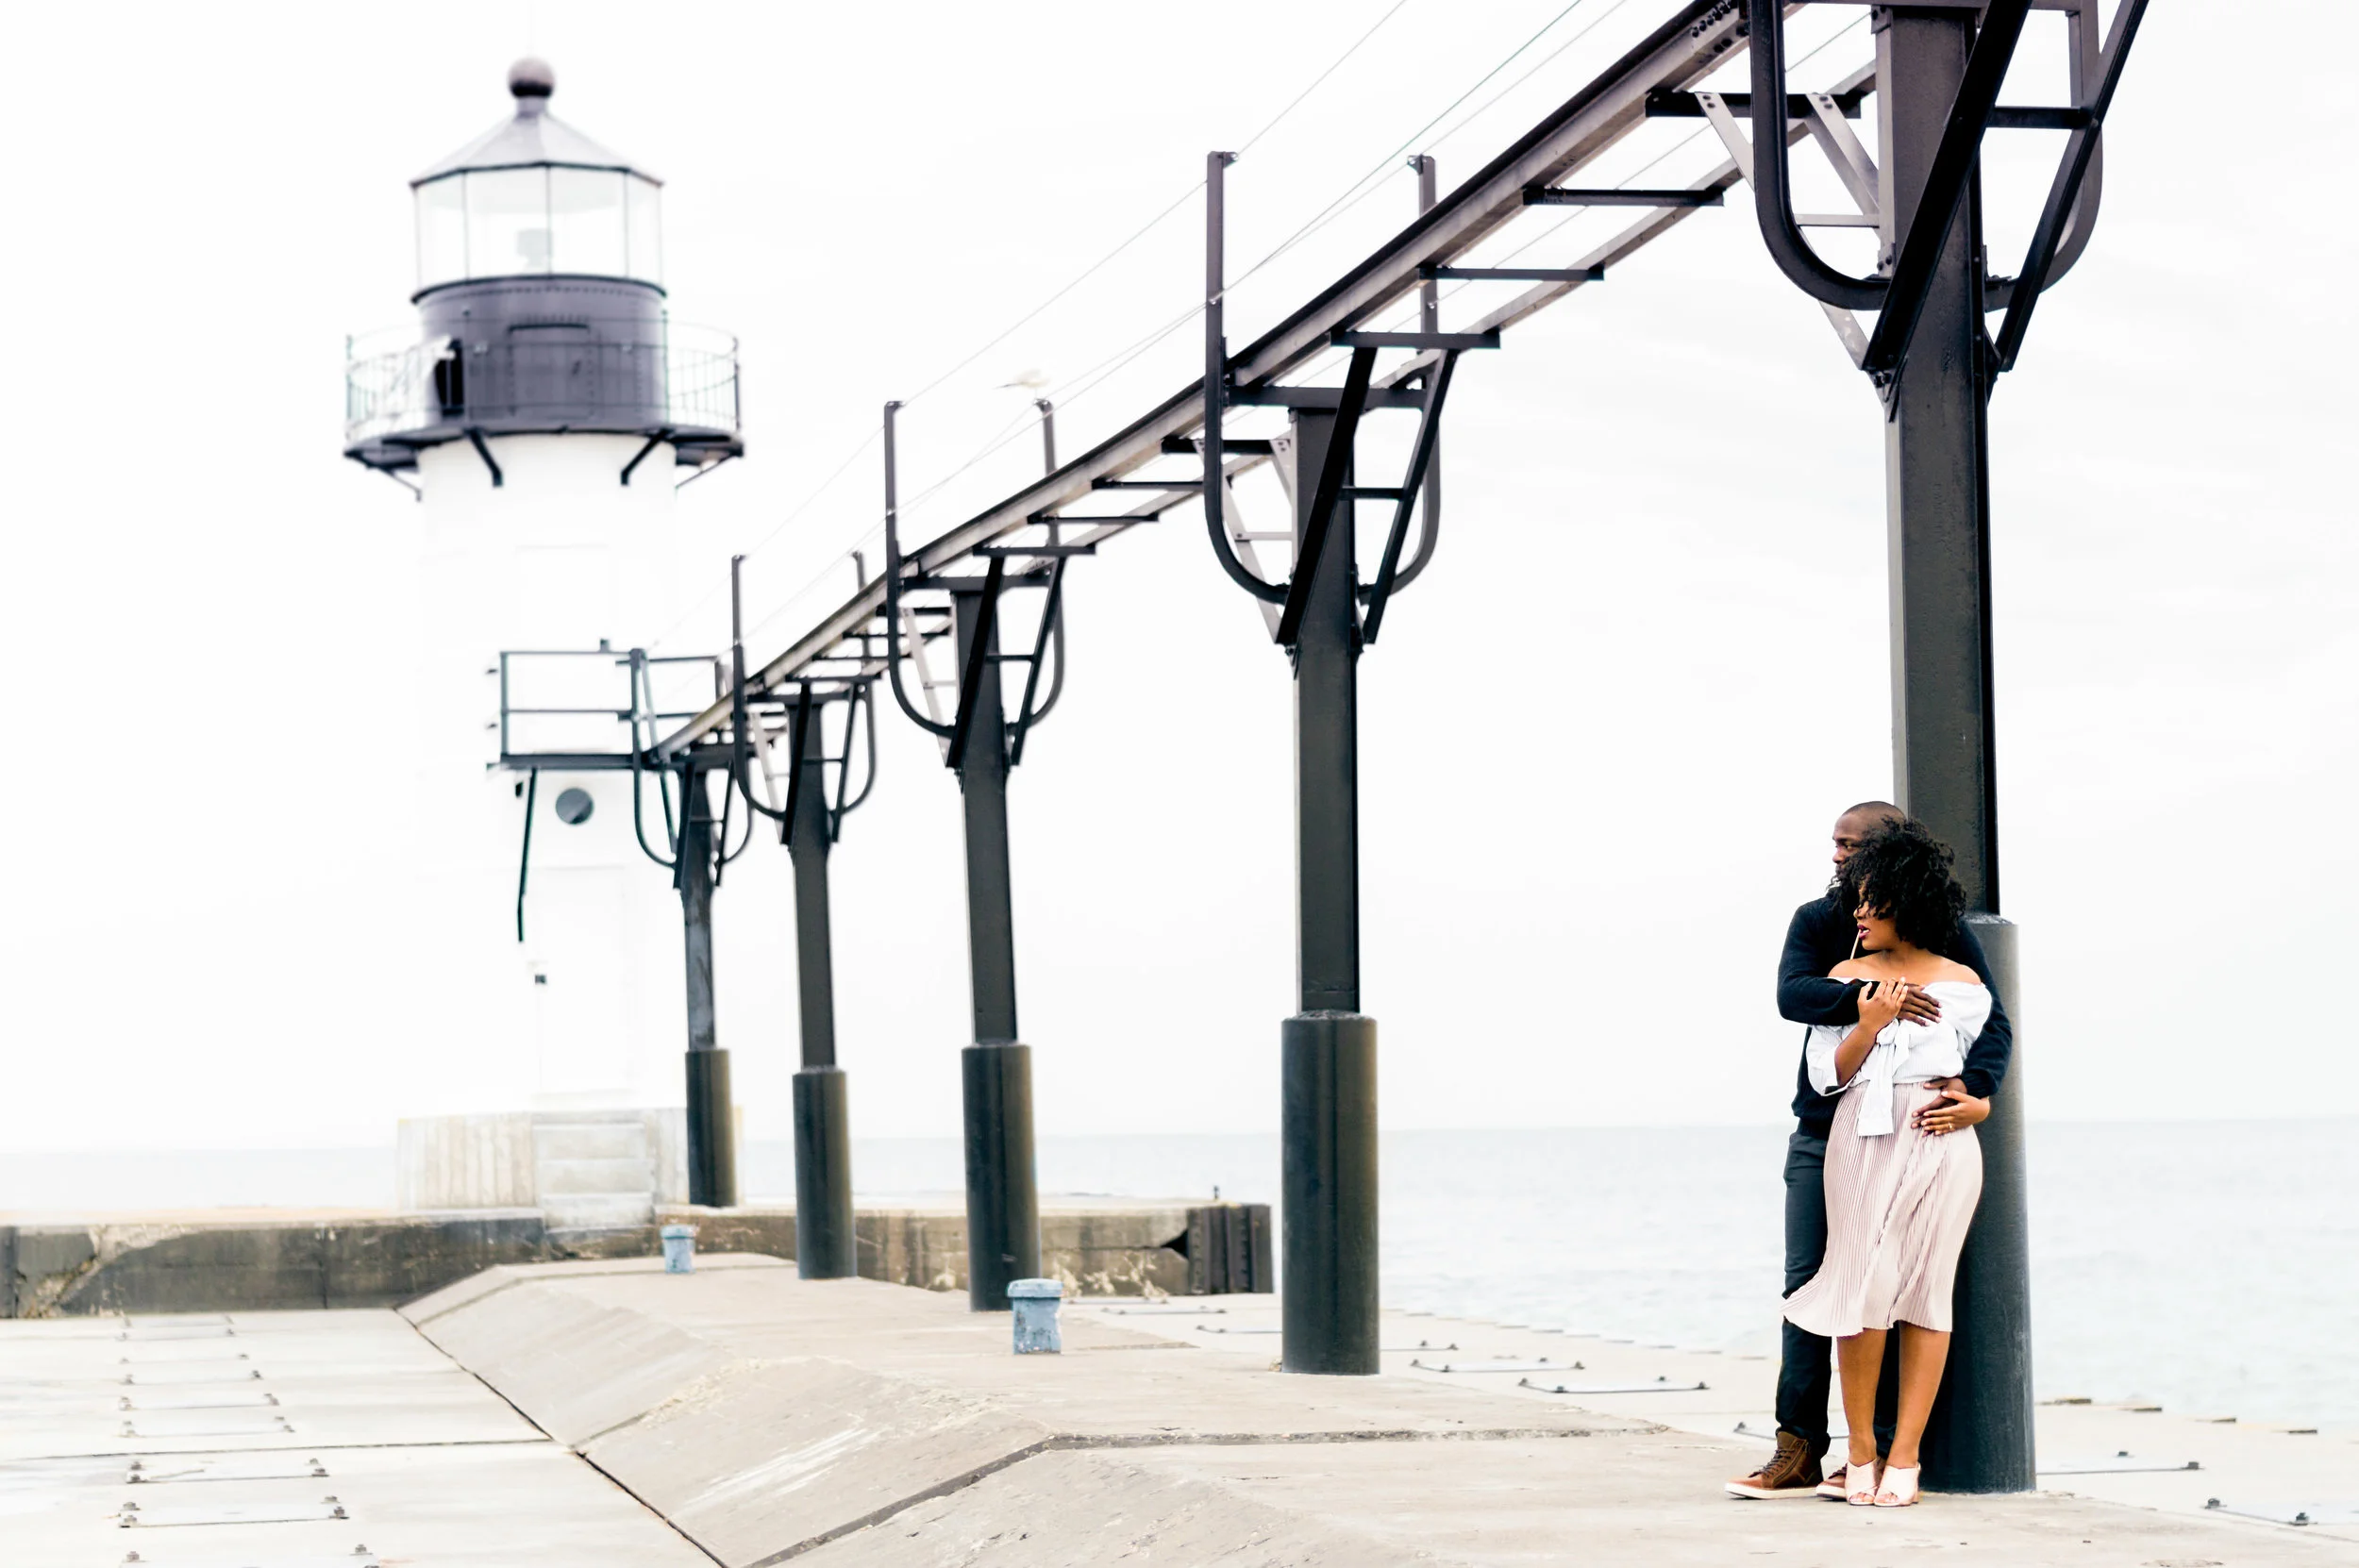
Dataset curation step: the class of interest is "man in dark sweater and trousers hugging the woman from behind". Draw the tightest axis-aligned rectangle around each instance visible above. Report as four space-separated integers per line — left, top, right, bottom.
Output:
1727 799 2015 1500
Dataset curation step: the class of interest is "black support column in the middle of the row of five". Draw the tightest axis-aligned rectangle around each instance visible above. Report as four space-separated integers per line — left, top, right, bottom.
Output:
953 590 1041 1311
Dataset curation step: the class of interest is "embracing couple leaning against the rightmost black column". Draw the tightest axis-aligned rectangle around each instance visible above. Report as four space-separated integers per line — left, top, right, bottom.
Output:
1727 802 2013 1510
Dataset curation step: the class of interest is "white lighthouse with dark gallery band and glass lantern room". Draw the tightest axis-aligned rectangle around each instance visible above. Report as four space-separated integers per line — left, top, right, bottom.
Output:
344 58 744 1233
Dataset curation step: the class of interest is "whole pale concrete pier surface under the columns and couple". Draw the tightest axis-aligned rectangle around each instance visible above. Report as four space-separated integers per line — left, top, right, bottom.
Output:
0 1257 2359 1568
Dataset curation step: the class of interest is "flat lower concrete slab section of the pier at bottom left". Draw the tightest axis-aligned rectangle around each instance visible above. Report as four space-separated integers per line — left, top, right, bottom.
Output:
0 1311 711 1568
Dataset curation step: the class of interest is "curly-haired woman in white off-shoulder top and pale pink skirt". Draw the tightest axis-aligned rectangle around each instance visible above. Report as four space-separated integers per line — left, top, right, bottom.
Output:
1786 821 1991 1510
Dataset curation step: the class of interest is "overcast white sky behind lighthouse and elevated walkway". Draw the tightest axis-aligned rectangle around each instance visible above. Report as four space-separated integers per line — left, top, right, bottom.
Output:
0 0 2359 1148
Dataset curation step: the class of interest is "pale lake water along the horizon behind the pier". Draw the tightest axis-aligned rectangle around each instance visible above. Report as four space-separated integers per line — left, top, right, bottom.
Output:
0 1118 2359 1425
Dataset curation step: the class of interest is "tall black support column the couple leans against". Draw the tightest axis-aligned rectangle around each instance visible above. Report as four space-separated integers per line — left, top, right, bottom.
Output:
1876 7 2036 1493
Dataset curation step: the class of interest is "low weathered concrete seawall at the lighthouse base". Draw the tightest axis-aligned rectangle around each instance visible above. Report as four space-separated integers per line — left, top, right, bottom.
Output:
0 1198 1246 1318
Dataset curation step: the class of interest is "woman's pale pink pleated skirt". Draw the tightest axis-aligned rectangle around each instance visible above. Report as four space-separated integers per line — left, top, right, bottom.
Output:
1786 1085 1982 1340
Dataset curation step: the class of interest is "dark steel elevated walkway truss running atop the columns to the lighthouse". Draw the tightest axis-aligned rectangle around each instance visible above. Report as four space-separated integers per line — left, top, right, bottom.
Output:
649 0 2145 764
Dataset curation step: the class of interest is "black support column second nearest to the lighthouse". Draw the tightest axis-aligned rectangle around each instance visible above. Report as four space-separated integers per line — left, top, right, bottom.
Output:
788 703 859 1280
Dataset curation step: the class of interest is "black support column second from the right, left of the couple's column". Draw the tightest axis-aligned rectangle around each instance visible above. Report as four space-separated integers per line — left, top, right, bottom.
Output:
1279 410 1378 1375
